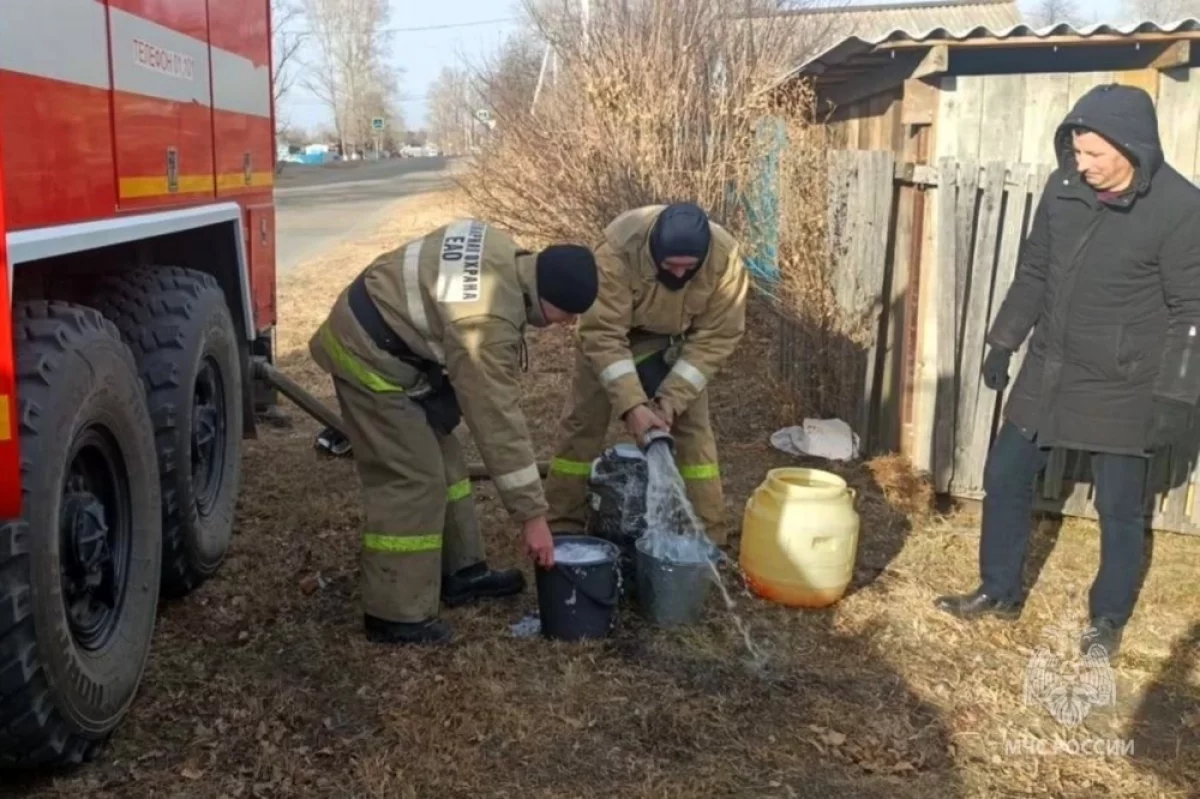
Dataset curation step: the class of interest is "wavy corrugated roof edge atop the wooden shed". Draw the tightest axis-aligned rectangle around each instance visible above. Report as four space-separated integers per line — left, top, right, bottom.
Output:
785 18 1200 79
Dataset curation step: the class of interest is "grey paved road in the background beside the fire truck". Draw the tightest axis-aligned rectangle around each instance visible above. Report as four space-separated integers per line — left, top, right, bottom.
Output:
275 158 450 274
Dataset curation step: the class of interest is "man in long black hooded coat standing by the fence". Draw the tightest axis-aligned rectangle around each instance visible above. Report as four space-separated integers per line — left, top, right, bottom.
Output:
936 84 1200 657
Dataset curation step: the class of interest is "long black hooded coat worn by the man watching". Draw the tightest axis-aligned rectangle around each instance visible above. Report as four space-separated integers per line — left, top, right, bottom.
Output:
988 85 1200 455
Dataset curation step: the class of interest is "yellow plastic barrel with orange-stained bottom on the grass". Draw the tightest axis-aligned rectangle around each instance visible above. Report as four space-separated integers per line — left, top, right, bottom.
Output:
739 468 859 608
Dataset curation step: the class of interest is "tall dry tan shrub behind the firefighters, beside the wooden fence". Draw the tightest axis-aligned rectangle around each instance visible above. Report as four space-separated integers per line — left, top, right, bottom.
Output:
462 0 859 413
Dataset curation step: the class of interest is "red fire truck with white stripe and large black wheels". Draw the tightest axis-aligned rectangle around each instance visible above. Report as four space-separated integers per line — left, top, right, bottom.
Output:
0 0 275 767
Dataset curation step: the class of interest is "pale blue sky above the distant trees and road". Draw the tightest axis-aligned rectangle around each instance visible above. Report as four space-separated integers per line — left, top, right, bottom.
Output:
280 0 1122 130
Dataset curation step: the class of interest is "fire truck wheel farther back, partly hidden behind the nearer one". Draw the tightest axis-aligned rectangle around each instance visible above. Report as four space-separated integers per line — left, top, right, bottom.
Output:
96 266 242 597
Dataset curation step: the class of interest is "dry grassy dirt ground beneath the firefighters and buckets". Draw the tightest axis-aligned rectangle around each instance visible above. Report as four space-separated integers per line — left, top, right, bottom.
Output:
9 188 1200 799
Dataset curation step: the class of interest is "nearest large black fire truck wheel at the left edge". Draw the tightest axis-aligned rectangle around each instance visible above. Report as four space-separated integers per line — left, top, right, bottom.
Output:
0 302 162 767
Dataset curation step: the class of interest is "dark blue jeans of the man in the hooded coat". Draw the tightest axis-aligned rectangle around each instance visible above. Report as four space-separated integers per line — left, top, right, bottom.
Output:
979 421 1150 625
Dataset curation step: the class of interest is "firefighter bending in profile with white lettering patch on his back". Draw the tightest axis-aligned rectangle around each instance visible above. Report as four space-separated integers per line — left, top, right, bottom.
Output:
310 220 596 643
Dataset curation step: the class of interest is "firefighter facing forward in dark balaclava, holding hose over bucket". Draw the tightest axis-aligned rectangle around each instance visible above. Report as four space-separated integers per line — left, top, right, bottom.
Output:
546 203 749 546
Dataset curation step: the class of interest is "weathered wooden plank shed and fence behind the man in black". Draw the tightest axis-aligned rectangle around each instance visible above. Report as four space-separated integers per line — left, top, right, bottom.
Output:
772 19 1200 531
